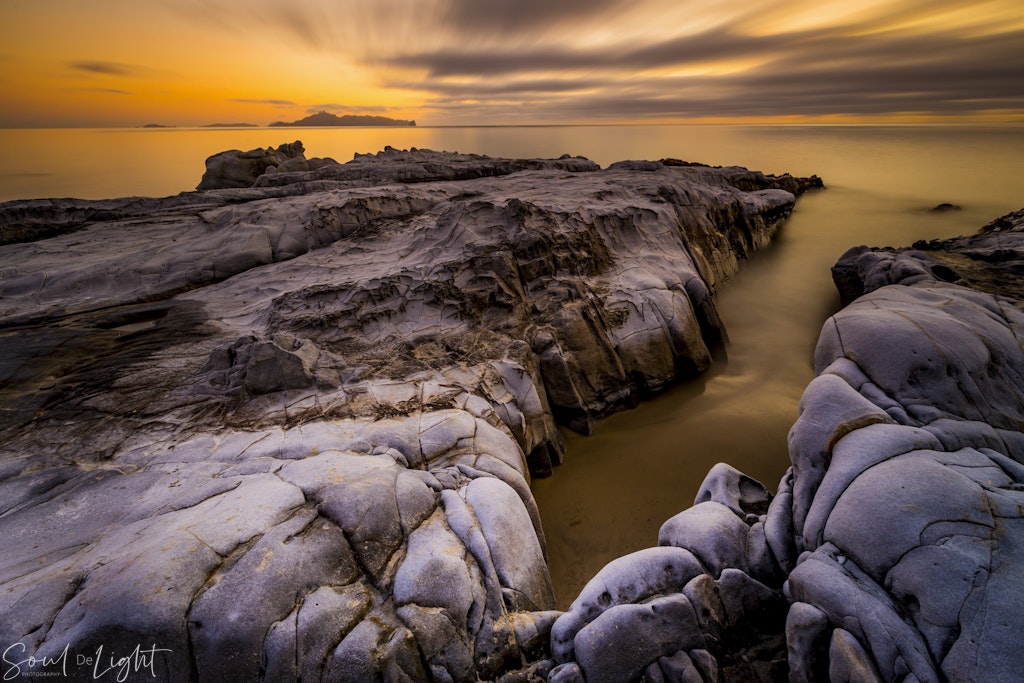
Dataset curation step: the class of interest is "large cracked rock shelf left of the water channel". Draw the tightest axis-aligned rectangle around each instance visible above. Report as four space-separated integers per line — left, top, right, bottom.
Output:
0 145 815 681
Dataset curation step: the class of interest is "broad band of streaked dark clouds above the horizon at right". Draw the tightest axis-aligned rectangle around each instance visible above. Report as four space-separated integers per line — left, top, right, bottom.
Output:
400 14 1024 120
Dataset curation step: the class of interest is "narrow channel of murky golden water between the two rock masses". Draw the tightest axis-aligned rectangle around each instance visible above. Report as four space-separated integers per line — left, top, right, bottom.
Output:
532 178 1024 609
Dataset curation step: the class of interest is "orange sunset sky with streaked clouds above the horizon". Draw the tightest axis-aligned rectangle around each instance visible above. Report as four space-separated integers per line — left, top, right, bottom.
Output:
0 0 1024 128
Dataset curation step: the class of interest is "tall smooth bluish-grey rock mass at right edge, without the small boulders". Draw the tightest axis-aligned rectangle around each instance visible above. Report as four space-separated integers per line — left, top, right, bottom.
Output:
788 212 1024 681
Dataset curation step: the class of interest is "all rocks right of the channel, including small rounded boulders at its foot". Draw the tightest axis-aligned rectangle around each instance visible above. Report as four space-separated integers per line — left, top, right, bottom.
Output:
550 211 1024 683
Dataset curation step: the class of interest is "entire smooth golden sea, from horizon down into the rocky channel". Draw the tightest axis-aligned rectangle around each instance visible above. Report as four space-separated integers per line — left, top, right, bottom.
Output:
0 123 1024 608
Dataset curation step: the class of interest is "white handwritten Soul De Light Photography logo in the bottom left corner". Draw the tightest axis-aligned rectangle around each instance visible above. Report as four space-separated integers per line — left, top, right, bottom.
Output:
0 643 172 683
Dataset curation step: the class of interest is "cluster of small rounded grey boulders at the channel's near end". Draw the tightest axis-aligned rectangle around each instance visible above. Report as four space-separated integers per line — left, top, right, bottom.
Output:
550 465 791 683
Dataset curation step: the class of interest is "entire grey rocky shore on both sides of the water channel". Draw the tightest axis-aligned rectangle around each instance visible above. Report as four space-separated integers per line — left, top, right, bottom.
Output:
0 142 1024 683
